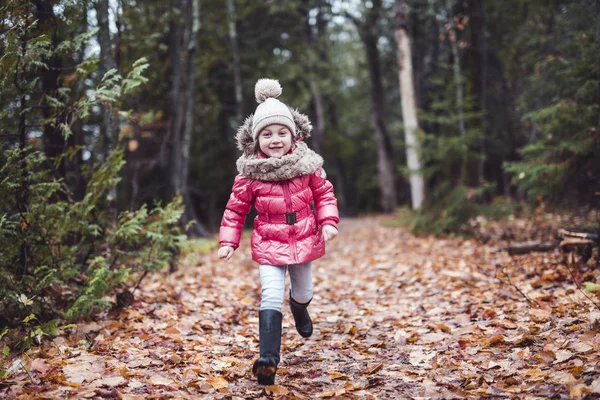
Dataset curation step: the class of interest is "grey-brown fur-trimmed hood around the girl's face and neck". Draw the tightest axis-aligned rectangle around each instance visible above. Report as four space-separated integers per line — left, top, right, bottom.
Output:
236 108 323 181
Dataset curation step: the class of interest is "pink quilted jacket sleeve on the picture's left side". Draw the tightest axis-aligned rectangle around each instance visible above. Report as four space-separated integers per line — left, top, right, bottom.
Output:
219 175 254 249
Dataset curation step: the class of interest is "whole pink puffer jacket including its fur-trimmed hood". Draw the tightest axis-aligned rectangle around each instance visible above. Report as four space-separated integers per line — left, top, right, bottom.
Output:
219 109 339 265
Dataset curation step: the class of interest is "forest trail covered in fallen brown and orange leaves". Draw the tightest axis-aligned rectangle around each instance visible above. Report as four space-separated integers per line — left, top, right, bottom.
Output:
0 217 600 399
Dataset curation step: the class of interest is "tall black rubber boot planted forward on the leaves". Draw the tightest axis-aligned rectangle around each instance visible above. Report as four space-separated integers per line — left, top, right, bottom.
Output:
252 310 283 385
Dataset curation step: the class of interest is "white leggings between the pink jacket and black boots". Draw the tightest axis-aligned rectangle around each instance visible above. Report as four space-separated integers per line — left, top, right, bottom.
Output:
259 263 313 311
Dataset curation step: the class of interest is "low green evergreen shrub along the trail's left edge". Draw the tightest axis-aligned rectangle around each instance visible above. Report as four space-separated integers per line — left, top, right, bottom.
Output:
0 149 186 347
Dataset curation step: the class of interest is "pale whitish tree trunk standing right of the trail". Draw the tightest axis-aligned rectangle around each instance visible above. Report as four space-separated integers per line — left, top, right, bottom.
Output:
396 0 425 210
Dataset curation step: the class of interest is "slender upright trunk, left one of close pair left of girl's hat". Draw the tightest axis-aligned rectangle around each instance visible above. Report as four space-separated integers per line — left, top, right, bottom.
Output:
169 0 186 195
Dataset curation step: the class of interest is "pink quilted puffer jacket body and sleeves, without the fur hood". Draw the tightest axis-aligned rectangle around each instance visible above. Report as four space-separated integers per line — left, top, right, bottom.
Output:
219 169 339 265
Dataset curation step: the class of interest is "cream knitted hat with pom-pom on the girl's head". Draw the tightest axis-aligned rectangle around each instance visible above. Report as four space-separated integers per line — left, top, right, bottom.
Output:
252 78 296 141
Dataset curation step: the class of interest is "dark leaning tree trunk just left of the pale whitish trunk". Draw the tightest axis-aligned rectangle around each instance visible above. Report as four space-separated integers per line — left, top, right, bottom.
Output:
352 0 397 212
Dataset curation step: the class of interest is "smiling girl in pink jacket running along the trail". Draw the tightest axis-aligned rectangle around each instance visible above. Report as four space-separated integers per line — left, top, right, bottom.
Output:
218 79 339 385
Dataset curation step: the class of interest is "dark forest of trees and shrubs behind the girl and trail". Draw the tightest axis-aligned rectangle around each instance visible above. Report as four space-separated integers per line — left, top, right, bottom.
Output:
0 0 600 352
